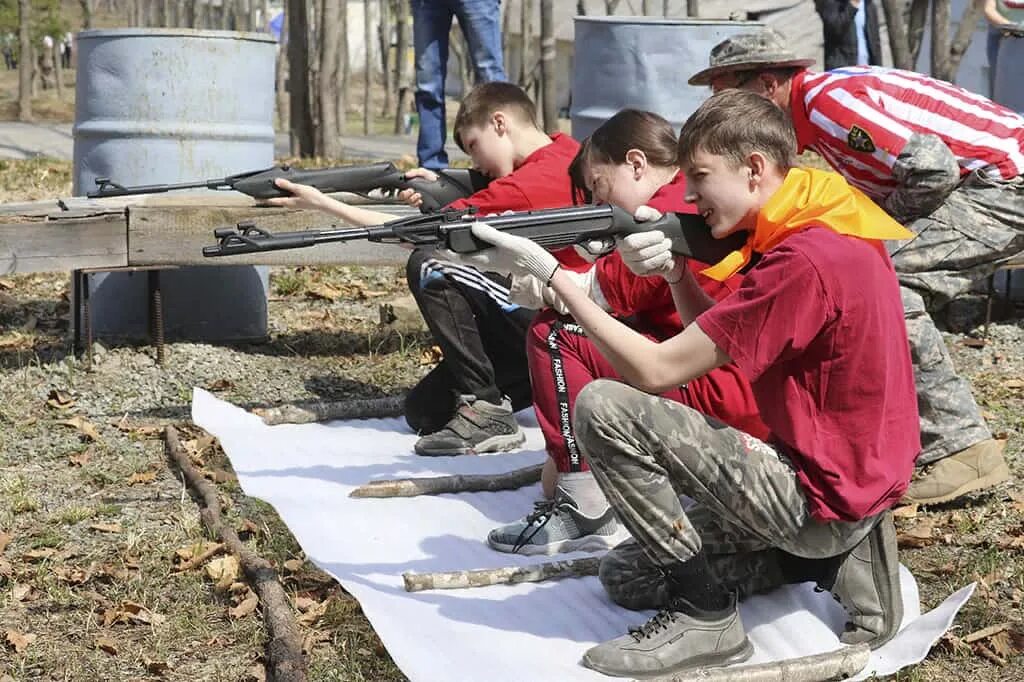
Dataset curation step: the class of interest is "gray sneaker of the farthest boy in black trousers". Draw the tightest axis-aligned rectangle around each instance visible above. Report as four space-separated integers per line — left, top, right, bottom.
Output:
415 395 526 457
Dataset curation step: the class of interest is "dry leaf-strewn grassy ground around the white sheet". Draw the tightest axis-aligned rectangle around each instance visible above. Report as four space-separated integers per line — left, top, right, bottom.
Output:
0 160 1024 682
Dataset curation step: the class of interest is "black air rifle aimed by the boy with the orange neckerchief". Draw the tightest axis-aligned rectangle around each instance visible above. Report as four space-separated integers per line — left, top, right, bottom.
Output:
203 205 746 263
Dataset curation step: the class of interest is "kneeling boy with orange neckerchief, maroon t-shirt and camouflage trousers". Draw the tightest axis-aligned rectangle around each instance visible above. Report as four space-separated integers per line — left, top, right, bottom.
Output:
448 90 921 677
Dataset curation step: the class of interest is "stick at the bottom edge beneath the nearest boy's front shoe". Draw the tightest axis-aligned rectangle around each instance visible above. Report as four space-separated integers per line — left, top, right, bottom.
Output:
647 644 871 682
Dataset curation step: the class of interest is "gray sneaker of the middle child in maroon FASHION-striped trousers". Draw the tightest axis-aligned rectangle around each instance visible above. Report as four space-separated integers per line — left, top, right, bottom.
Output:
487 487 629 554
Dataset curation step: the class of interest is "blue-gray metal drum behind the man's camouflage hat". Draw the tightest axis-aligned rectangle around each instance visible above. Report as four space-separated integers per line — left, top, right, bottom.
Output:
569 16 764 139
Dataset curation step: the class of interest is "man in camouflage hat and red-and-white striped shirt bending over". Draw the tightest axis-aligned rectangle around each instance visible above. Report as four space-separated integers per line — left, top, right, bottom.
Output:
689 30 1024 504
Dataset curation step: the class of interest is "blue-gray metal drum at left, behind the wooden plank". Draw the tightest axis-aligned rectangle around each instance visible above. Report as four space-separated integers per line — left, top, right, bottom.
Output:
74 29 276 341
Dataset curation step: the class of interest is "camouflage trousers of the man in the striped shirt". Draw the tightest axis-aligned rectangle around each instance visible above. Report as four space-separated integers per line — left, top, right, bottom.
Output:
889 172 1024 466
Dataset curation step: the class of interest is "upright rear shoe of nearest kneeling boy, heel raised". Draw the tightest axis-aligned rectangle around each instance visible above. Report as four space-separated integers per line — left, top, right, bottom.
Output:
822 511 903 649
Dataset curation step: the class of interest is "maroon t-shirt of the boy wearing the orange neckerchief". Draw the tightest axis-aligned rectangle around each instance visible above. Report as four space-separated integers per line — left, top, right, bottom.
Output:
696 227 921 521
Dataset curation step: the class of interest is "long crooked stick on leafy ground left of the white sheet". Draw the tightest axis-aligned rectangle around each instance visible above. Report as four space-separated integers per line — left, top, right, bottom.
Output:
164 426 306 682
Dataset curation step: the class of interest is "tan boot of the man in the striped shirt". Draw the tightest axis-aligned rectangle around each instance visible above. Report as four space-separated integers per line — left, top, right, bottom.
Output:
900 438 1010 505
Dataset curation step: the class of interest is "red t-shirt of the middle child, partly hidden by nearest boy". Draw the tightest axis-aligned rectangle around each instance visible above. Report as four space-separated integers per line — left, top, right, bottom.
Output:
595 173 769 440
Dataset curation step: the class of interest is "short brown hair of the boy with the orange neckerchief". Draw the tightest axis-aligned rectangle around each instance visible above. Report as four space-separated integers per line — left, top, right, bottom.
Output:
679 90 797 172
